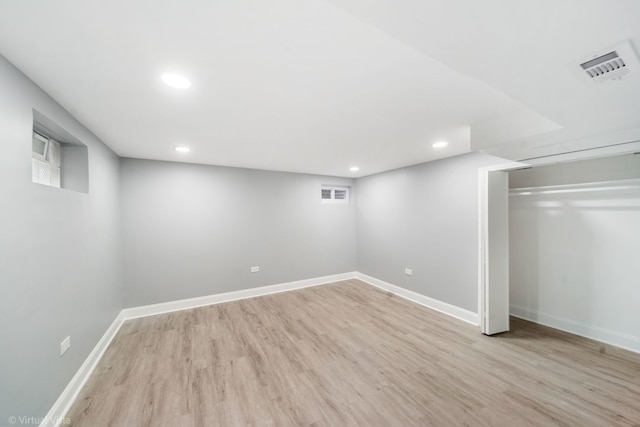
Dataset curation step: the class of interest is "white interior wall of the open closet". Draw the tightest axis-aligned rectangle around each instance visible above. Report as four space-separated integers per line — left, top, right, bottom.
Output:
509 155 640 351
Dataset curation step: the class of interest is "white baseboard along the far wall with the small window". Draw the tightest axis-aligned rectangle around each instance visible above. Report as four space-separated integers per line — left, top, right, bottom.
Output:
122 272 356 320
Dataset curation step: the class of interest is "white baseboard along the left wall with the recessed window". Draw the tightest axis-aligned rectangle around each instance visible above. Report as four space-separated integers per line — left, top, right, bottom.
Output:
40 312 124 427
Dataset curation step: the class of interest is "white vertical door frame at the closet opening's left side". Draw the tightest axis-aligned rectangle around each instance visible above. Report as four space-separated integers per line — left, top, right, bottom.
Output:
478 162 529 334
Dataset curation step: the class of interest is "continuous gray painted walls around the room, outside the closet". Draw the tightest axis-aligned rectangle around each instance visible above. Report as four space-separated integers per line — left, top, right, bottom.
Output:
0 53 516 425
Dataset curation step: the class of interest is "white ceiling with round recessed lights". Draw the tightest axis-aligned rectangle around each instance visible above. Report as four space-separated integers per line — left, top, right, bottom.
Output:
0 0 640 176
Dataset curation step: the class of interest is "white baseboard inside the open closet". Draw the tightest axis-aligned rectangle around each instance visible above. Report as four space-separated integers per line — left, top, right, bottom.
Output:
509 304 640 353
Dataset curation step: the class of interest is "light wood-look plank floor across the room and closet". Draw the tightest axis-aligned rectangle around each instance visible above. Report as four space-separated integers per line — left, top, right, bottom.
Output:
68 280 640 427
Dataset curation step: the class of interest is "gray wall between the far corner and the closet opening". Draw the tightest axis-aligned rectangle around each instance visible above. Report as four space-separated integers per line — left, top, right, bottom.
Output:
356 153 505 313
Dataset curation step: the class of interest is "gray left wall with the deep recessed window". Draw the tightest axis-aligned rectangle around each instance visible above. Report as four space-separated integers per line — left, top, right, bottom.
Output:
0 56 123 425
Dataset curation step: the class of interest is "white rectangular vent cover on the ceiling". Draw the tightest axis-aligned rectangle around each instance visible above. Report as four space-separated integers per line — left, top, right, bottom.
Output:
580 41 640 83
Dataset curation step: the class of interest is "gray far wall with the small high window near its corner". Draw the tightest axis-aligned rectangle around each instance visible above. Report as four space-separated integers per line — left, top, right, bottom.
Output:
121 159 356 307
